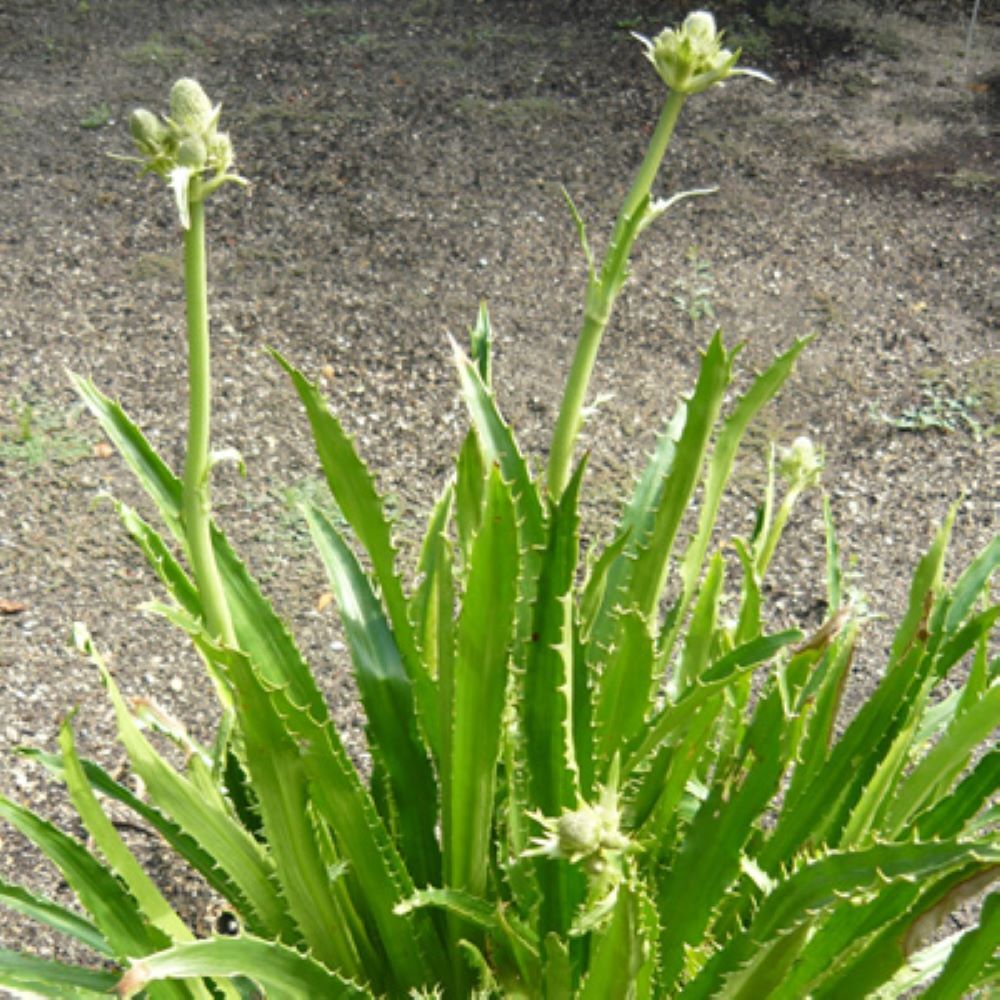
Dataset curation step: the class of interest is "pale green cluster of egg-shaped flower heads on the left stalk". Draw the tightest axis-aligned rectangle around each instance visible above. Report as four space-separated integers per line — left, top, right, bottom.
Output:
129 77 246 229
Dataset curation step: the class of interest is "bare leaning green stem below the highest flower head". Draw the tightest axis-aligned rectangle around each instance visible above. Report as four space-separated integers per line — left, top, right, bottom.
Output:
548 91 685 498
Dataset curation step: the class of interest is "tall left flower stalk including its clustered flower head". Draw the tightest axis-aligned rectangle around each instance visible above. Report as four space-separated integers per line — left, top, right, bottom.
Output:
130 79 245 647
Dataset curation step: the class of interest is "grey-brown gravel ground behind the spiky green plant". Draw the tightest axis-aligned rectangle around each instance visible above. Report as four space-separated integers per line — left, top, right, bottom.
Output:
0 0 1000 972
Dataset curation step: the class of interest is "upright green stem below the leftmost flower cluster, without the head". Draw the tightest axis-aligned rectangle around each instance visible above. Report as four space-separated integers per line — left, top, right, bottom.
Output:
183 186 236 647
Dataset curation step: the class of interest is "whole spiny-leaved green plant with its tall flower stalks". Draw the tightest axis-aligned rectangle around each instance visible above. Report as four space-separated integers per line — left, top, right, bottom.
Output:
0 13 1000 1000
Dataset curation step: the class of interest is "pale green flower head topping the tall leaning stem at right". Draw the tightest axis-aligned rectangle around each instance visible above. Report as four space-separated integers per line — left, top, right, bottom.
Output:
635 10 768 95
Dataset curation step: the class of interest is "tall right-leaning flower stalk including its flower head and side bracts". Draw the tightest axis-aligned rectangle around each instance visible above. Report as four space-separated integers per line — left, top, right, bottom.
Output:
548 11 766 497
